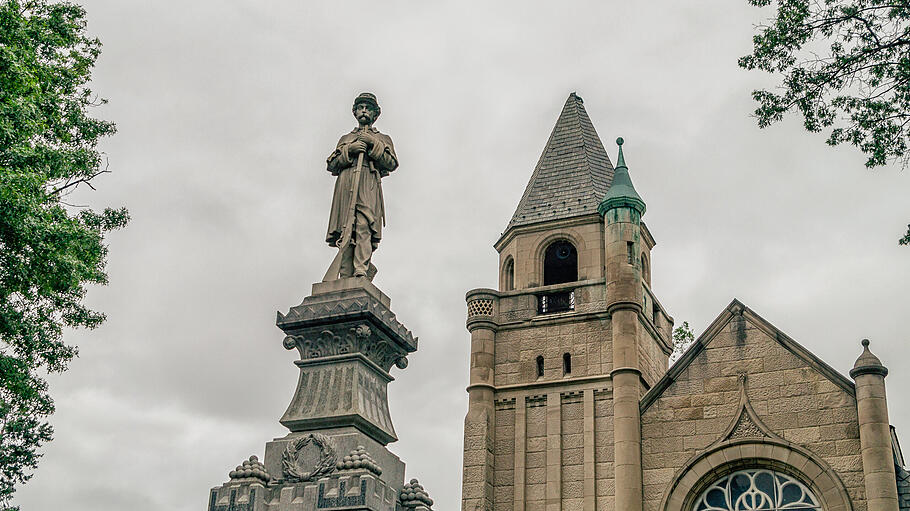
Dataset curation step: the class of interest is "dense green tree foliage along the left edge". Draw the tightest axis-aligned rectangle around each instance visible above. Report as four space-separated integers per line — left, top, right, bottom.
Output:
0 0 128 509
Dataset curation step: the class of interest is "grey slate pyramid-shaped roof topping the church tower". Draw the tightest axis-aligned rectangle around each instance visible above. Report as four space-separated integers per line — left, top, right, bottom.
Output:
507 92 613 229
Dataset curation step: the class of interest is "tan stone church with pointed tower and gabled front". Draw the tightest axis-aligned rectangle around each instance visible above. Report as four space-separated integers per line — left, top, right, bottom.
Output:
462 93 910 511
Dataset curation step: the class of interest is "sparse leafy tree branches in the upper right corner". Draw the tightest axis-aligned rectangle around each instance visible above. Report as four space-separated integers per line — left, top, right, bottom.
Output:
739 0 910 245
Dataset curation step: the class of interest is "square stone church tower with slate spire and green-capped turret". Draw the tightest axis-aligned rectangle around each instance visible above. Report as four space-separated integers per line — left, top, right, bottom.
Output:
463 94 673 511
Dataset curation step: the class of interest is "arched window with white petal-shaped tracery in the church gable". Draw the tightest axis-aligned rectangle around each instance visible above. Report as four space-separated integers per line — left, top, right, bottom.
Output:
692 469 821 511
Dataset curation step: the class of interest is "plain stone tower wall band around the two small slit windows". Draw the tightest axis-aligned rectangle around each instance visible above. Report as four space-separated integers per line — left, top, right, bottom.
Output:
494 318 613 386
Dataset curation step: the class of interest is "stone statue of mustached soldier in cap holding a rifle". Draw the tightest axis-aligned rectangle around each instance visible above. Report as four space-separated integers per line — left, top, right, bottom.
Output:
323 92 398 281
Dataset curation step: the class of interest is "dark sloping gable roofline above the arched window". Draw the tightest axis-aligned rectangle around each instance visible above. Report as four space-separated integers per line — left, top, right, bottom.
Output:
640 298 856 413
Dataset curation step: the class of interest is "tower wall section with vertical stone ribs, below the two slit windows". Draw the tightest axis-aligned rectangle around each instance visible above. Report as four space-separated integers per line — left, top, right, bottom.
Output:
493 390 614 511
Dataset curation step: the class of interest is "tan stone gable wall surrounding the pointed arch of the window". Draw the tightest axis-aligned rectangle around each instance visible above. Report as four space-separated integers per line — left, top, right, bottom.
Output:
642 316 866 511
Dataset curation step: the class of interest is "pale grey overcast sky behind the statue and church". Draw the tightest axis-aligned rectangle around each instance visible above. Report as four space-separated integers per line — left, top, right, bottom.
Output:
16 0 910 511
